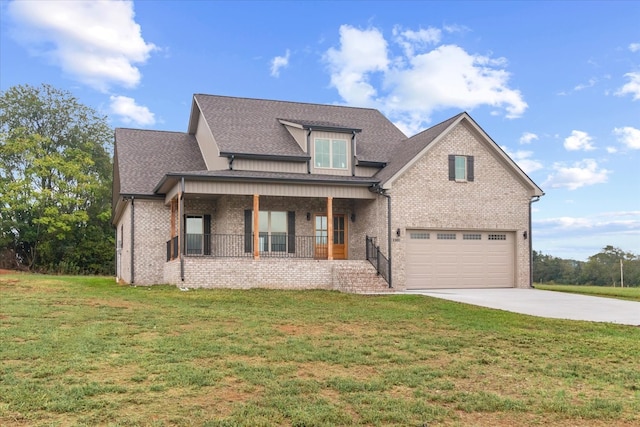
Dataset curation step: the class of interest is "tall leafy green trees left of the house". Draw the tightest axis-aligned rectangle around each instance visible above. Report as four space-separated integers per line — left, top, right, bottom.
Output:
0 84 114 274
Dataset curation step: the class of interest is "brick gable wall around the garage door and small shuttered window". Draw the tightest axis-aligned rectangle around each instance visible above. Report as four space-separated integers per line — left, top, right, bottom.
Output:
388 124 531 289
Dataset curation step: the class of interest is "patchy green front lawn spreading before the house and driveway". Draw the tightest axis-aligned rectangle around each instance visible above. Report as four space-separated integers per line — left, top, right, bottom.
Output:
0 275 640 426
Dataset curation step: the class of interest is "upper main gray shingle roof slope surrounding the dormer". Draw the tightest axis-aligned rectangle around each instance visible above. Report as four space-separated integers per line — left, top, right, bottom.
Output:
190 94 406 161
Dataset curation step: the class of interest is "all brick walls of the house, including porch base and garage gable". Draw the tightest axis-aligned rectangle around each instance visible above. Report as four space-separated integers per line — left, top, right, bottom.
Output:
117 124 531 292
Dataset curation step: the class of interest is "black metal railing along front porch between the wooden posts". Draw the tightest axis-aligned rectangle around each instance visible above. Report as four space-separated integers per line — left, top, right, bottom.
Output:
167 233 327 260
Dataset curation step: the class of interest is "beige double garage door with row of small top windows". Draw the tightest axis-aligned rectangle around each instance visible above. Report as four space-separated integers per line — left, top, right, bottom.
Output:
406 230 515 289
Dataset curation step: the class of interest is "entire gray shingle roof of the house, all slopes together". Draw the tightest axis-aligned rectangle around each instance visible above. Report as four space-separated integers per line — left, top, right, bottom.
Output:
114 95 460 200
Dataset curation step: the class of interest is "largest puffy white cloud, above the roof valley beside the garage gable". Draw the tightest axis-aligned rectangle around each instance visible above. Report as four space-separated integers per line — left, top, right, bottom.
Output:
325 25 527 133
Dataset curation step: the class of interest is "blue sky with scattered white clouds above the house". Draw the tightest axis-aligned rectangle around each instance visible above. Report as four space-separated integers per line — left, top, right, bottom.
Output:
0 0 640 260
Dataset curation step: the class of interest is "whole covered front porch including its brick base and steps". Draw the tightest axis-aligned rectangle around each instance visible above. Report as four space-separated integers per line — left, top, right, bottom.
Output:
156 174 387 290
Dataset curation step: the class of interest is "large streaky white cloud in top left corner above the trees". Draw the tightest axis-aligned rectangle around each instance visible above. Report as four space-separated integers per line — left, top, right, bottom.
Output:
8 0 157 91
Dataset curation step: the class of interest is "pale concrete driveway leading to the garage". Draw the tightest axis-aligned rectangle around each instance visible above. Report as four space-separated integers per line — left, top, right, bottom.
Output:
399 288 640 326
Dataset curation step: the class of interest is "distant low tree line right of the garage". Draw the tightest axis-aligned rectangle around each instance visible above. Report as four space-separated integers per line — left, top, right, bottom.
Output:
533 246 640 287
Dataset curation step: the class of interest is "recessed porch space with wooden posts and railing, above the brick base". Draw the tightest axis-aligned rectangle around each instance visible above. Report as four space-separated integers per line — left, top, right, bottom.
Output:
166 195 372 261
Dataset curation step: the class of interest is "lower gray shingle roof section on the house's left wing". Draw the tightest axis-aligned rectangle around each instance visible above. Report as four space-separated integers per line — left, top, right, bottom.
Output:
115 128 207 195
